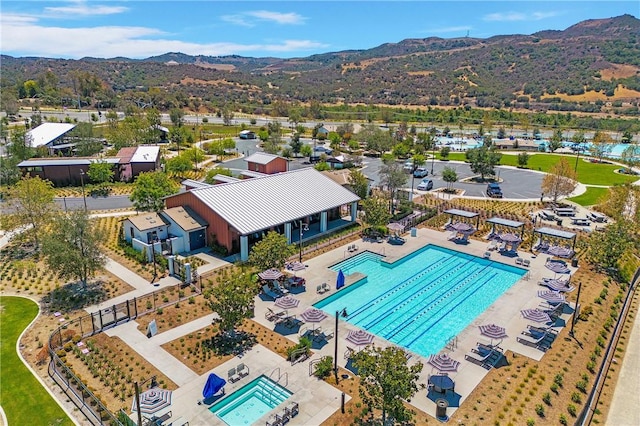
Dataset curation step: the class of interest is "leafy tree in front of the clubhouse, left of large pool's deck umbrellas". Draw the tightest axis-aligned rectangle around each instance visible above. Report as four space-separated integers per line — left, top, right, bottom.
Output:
209 269 257 334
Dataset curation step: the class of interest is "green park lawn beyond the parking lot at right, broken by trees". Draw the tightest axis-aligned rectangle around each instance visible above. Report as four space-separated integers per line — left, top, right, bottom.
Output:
438 152 638 186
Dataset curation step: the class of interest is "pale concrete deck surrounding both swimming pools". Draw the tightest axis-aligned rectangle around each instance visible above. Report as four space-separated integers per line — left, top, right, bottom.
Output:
114 228 574 425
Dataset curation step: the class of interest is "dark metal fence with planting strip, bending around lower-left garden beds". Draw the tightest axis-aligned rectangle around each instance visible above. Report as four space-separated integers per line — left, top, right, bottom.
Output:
48 283 202 426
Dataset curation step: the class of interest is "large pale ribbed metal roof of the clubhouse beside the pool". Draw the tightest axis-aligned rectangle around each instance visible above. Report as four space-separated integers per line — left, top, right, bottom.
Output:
191 167 360 235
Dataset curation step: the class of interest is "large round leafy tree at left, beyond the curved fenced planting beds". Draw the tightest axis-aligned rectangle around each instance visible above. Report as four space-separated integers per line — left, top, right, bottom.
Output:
42 209 106 289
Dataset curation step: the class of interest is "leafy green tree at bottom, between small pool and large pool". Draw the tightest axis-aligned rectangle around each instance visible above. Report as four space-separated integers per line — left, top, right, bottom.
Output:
353 346 422 425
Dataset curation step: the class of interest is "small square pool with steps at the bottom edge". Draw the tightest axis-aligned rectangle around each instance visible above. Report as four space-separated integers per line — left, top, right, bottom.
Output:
209 375 292 426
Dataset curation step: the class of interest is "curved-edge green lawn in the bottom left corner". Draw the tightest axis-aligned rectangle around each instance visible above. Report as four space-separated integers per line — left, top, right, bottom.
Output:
0 296 73 425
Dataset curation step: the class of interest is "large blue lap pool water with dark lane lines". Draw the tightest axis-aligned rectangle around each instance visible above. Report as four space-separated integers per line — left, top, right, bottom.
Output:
314 245 526 357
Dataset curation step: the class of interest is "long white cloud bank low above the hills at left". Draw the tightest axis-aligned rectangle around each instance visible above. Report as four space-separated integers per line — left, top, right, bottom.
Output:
2 20 327 58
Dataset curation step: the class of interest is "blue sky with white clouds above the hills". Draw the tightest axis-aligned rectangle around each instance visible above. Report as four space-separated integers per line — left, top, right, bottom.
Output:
0 0 640 59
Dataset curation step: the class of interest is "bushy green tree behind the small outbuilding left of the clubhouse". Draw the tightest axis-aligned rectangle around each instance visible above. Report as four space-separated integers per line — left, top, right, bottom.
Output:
129 171 179 212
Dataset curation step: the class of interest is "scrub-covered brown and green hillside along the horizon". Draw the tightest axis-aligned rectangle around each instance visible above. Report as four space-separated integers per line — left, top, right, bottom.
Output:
1 15 640 114
